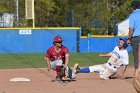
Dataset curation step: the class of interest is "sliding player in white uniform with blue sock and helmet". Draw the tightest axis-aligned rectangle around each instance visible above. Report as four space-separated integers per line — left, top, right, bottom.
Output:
74 38 129 80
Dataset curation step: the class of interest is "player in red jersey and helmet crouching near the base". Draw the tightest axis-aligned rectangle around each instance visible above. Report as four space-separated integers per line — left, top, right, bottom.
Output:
45 36 76 81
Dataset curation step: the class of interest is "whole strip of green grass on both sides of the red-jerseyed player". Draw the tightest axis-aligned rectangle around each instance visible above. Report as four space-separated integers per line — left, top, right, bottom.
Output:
0 53 133 69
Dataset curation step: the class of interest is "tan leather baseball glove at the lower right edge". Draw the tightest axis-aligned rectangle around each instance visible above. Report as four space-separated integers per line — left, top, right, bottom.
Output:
133 70 140 93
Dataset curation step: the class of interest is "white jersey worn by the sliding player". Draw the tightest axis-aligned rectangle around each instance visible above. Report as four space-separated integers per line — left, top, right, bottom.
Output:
108 46 129 67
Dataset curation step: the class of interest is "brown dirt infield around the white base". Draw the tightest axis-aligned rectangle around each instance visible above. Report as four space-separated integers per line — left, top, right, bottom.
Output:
0 67 136 93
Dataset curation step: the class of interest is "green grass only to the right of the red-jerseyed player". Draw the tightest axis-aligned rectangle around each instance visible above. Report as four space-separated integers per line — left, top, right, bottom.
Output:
70 53 133 66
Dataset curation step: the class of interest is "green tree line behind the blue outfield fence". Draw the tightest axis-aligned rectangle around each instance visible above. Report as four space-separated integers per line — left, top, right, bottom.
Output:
0 0 136 35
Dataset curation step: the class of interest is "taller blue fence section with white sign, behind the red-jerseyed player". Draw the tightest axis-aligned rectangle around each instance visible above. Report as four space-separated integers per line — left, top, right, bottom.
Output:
0 28 80 53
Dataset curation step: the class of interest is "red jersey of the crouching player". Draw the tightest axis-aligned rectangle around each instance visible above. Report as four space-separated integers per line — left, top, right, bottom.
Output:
46 46 69 64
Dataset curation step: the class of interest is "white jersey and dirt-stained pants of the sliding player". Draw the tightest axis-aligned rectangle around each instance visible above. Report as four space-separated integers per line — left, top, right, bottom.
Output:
89 46 129 79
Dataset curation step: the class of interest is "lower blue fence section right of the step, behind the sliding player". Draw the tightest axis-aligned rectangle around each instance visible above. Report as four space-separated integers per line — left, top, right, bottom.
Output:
80 36 132 52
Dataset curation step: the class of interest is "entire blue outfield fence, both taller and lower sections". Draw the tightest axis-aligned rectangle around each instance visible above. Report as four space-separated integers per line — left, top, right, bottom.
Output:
0 27 132 53
